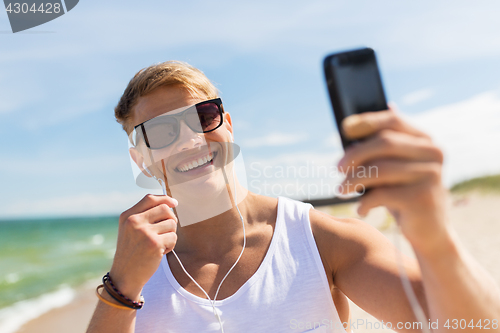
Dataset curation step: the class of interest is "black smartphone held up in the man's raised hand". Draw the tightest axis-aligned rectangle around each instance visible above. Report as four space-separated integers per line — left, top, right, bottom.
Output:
323 48 388 149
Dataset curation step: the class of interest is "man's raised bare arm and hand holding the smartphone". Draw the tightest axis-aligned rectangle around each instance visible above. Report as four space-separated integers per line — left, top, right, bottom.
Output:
316 110 500 332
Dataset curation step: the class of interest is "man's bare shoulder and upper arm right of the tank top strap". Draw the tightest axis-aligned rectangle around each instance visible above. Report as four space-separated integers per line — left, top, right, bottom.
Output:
310 209 428 332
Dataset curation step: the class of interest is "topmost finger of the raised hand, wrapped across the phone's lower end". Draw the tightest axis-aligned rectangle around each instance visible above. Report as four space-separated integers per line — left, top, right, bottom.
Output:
342 106 429 139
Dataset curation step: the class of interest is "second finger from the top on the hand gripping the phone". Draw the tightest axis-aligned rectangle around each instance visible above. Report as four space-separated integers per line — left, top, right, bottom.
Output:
338 130 443 171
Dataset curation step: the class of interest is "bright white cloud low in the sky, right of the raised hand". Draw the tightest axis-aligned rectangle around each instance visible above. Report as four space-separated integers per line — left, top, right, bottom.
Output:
409 91 500 186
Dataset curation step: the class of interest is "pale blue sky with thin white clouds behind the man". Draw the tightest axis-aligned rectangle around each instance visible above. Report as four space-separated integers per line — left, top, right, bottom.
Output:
0 0 500 218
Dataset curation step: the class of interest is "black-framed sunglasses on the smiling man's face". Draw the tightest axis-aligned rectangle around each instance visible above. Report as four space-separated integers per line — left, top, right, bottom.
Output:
134 98 224 149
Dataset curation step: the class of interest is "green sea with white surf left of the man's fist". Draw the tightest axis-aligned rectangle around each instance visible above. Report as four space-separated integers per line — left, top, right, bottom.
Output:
0 216 118 333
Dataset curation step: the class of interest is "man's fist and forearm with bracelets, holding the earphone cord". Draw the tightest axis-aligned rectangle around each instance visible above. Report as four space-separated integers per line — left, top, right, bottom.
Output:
87 195 177 333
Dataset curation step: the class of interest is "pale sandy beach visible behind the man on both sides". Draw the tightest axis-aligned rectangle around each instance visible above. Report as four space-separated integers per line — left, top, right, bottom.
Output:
18 194 500 333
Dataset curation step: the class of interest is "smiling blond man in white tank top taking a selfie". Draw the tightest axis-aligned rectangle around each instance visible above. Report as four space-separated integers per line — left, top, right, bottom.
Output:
88 61 500 332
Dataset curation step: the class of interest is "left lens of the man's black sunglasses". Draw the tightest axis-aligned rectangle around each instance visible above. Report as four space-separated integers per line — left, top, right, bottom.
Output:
144 116 179 149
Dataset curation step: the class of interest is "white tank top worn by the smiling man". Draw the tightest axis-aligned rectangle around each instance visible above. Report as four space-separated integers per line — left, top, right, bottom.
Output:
135 197 346 333
